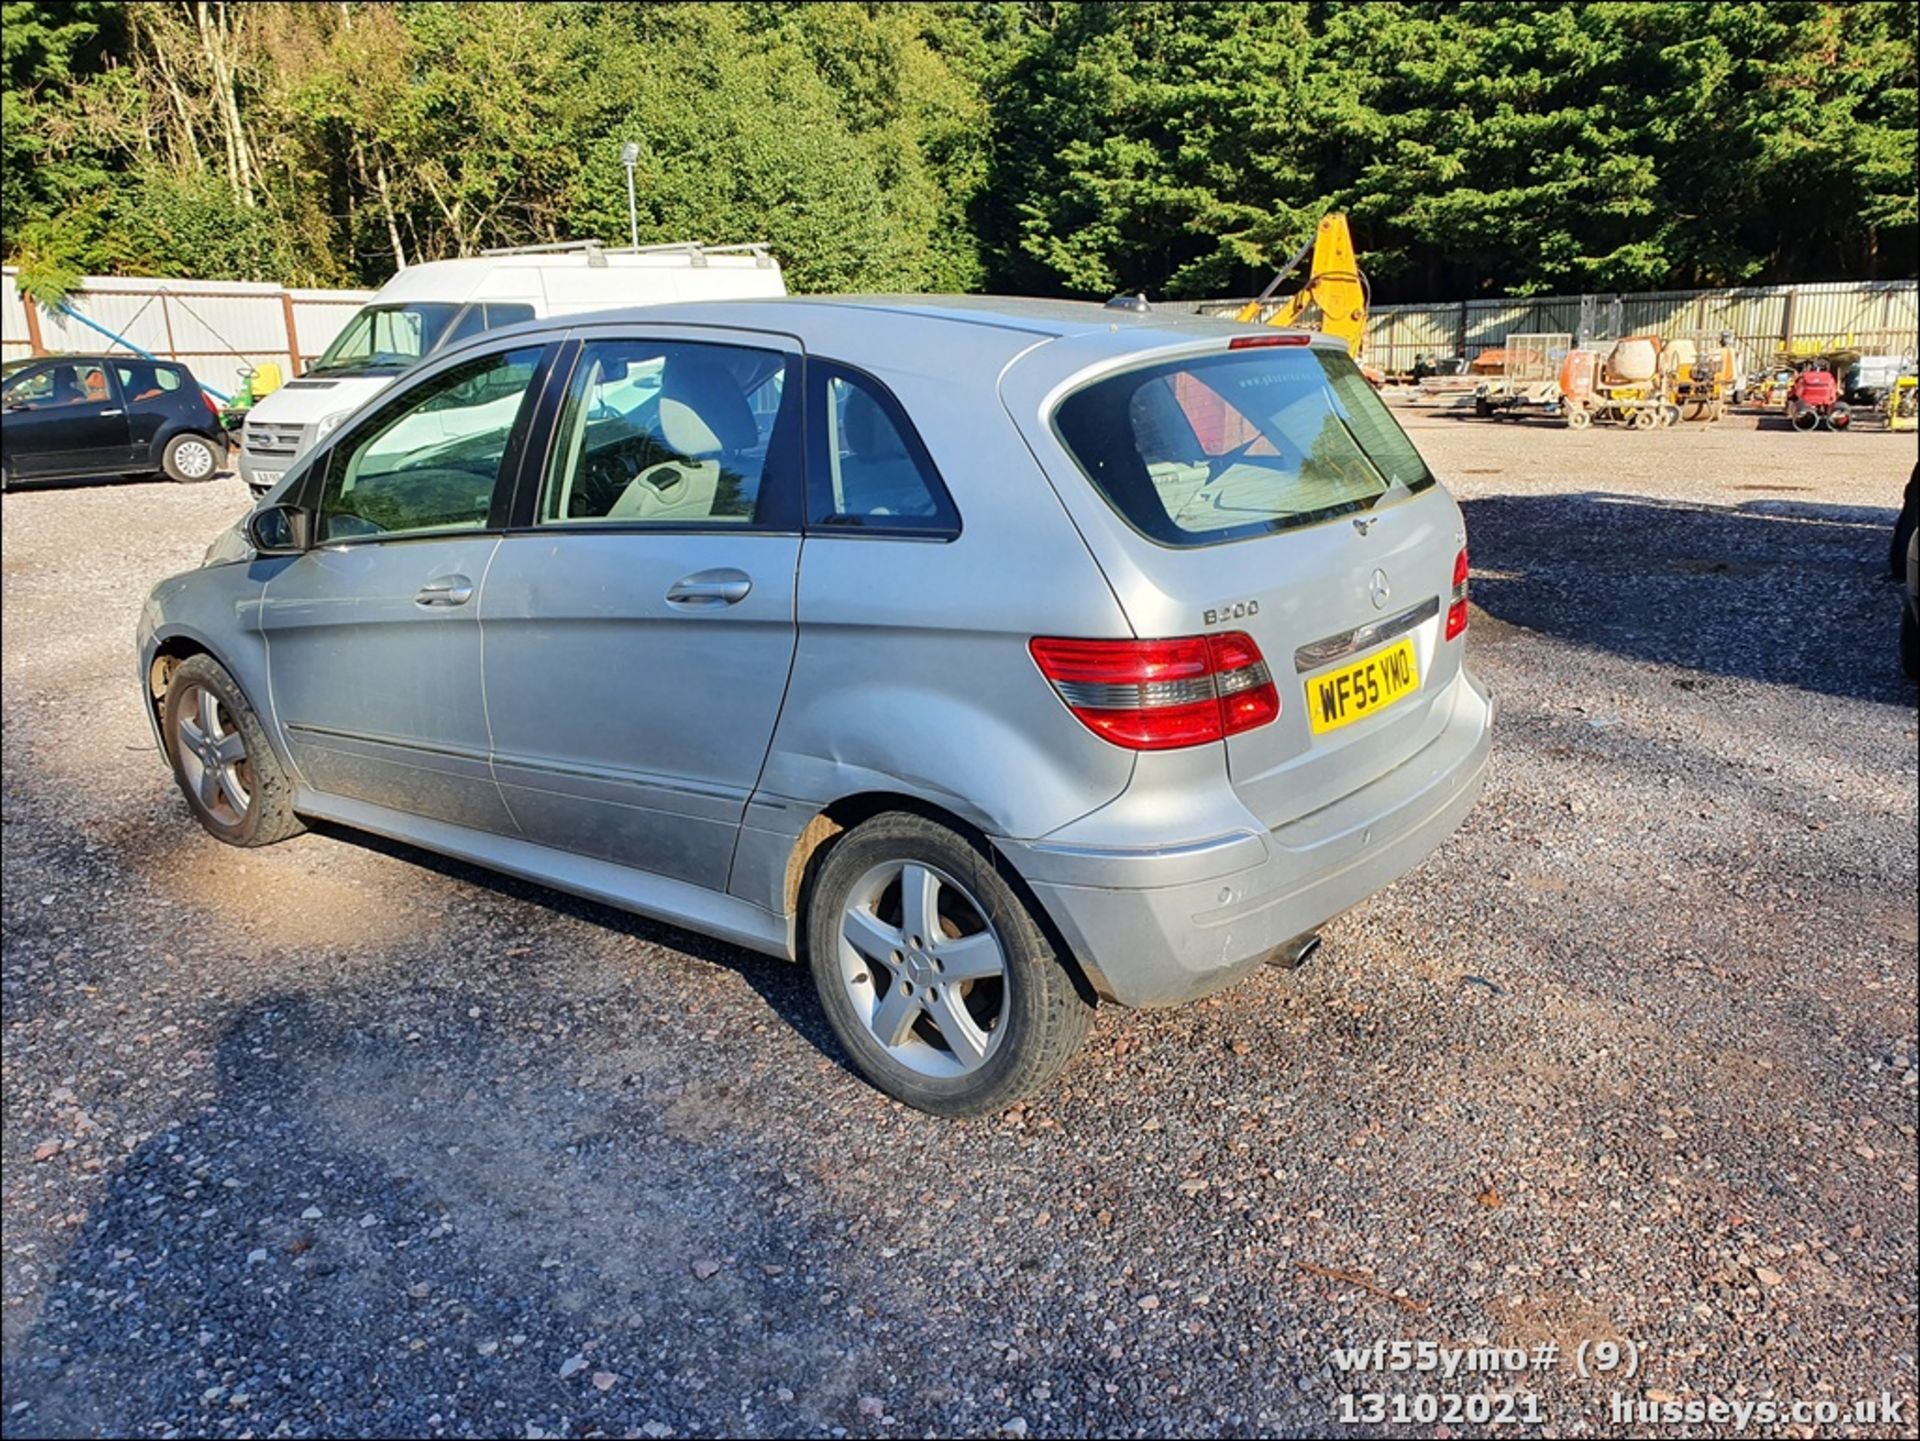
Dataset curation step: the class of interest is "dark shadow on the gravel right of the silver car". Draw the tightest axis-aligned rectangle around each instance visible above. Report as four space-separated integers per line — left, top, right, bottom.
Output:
1461 491 1912 704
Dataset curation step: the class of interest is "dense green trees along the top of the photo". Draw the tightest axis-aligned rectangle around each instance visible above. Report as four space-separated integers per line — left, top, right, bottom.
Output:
0 0 1920 299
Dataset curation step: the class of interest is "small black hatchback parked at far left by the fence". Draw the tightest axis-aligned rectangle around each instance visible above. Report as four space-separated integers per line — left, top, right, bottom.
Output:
0 355 227 485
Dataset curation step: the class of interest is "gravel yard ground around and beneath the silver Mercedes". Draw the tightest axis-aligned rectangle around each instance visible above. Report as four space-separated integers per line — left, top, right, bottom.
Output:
0 407 1920 1437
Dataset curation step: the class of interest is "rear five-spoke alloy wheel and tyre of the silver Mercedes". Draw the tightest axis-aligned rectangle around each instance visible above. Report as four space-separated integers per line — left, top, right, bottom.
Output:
806 812 1094 1117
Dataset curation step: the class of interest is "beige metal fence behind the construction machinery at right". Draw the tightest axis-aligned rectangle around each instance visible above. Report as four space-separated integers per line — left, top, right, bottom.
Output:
1169 280 1920 370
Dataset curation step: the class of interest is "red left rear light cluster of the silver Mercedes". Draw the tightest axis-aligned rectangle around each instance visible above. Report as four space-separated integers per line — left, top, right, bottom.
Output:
1027 631 1281 750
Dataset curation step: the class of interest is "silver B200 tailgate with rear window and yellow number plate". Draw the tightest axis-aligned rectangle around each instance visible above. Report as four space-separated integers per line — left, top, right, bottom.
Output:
1002 330 1465 827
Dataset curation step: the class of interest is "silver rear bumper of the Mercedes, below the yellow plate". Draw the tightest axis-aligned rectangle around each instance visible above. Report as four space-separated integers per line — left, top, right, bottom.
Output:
998 673 1494 1005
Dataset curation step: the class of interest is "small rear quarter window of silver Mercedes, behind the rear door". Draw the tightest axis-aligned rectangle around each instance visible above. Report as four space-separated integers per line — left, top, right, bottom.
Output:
808 365 960 532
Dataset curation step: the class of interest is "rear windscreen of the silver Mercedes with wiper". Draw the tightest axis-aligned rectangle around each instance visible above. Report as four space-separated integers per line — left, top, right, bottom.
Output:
1054 345 1432 545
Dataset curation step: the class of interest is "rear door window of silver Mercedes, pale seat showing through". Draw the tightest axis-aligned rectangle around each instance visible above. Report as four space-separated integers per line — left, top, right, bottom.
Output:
536 340 787 526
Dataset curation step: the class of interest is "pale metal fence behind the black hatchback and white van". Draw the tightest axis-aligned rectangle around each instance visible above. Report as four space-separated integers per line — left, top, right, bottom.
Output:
0 267 372 395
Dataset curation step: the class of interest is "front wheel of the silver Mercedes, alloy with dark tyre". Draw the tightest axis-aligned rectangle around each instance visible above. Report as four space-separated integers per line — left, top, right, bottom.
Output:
161 654 305 846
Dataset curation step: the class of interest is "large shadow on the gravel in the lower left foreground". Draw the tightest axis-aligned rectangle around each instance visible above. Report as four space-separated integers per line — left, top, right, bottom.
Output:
4 988 898 1437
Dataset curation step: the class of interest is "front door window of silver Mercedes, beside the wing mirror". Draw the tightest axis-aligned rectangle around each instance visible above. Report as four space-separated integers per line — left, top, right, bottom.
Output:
319 345 540 541
